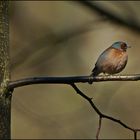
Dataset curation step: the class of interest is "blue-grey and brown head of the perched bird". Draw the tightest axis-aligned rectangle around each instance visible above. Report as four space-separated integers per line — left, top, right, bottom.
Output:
111 41 130 51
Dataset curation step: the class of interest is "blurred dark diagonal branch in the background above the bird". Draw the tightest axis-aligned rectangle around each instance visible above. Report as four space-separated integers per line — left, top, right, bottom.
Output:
75 1 140 33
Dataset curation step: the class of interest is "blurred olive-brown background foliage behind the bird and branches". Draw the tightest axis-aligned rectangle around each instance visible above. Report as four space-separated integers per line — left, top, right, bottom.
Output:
10 1 140 139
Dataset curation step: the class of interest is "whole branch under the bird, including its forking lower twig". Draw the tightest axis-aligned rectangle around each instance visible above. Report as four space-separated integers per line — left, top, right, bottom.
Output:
8 74 140 139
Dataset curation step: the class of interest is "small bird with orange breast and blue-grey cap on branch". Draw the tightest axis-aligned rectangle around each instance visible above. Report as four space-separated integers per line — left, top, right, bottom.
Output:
90 41 130 77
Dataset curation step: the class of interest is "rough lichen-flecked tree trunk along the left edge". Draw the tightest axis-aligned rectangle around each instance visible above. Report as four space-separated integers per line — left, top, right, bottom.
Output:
0 0 11 139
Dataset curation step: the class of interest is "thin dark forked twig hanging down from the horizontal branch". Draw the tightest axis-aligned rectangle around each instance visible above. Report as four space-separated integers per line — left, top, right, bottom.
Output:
70 83 140 139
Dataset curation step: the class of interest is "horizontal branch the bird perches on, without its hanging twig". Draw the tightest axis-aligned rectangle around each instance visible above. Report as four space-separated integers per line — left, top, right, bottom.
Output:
8 74 140 89
